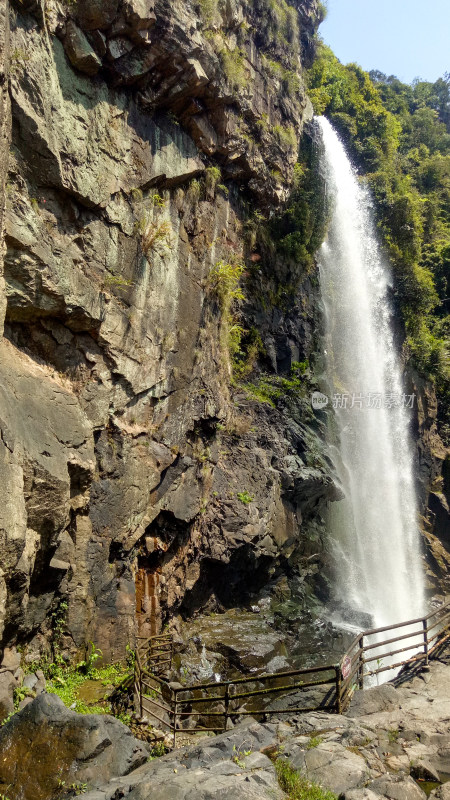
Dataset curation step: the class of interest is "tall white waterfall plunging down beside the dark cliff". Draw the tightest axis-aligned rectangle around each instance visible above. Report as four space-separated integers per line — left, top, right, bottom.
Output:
317 117 424 629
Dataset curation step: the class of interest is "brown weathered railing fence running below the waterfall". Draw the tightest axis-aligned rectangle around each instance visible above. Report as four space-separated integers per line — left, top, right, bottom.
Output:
135 601 450 746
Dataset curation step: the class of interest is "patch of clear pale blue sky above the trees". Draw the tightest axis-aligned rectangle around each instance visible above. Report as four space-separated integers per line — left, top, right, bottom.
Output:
319 0 450 83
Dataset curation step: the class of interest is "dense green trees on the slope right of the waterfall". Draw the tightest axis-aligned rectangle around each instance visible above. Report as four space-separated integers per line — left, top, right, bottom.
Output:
309 45 450 436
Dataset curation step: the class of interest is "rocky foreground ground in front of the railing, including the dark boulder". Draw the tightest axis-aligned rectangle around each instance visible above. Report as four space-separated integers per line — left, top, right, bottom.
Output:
0 650 450 800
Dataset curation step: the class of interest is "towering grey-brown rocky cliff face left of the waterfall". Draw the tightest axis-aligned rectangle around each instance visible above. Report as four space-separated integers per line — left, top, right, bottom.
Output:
0 0 335 660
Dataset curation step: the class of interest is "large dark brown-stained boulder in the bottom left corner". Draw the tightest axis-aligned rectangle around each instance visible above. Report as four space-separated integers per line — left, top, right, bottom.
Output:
0 694 148 800
